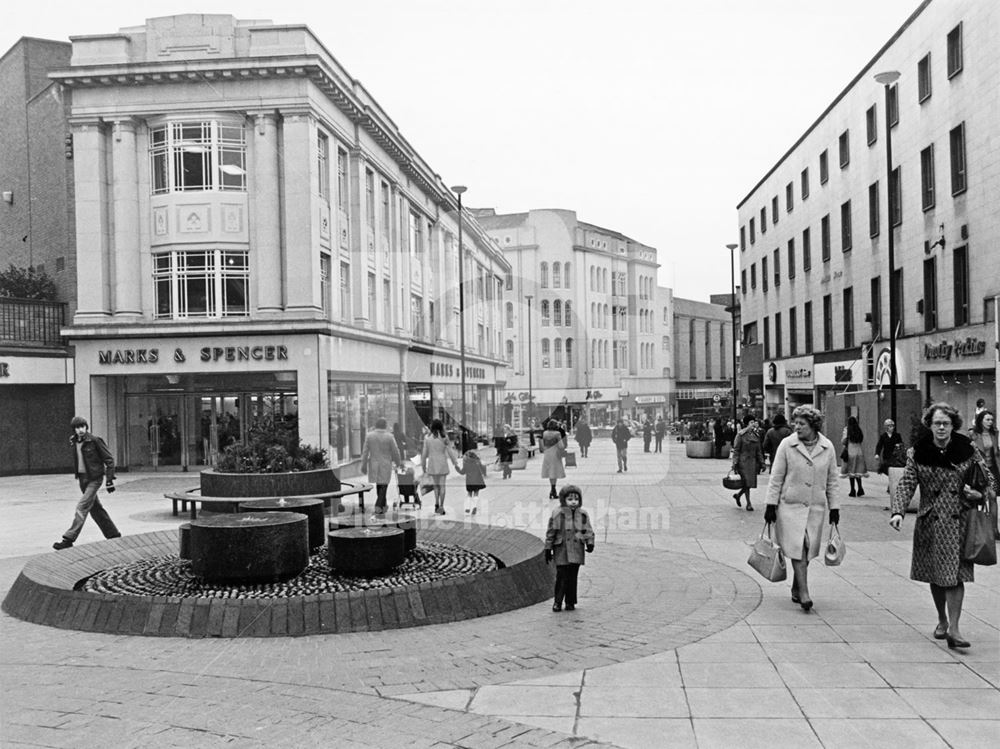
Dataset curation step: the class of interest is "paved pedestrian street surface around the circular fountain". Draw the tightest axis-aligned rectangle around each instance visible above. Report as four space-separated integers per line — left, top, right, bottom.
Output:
0 440 1000 749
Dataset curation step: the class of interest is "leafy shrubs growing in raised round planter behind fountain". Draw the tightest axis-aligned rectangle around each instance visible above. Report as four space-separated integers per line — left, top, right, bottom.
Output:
215 416 329 473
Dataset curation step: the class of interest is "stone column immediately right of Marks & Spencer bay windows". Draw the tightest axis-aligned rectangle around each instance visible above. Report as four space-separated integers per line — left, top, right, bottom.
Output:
250 113 283 315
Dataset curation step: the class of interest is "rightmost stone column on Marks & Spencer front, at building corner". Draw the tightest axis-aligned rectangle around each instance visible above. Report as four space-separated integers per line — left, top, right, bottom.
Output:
281 112 318 317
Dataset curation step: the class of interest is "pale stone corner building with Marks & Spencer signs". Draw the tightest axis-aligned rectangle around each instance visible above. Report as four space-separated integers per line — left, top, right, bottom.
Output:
45 15 510 469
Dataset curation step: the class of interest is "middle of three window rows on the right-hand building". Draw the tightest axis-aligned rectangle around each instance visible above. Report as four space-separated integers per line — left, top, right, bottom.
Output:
740 122 968 294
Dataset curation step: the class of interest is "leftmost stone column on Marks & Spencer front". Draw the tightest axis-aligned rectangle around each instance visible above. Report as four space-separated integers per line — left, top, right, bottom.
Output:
72 119 111 323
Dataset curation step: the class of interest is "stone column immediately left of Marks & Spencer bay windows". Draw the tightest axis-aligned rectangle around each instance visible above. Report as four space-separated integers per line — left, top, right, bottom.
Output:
111 118 143 318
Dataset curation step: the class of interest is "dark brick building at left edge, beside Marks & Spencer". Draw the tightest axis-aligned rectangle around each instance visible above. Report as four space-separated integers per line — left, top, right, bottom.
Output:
0 38 76 474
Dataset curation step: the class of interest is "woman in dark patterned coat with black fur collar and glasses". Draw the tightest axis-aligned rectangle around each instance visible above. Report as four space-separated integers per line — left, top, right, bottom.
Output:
889 402 996 650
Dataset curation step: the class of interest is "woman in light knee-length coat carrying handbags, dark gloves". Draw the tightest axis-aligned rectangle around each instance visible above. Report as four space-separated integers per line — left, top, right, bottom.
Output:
764 406 840 611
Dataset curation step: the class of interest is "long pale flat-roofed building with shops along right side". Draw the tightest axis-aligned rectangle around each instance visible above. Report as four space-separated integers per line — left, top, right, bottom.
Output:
738 0 1000 419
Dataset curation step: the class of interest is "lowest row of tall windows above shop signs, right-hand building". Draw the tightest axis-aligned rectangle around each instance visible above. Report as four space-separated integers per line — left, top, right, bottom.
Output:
743 245 976 359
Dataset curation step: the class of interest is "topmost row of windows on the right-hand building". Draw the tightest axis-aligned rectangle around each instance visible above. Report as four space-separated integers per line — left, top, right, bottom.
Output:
740 17 964 251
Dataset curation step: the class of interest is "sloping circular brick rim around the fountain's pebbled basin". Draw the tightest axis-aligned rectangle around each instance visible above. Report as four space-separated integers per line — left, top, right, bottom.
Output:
2 520 555 637
